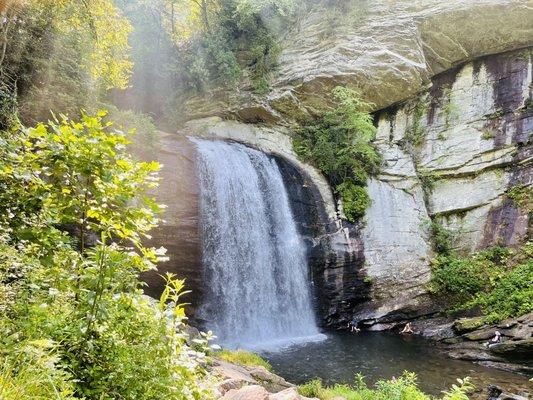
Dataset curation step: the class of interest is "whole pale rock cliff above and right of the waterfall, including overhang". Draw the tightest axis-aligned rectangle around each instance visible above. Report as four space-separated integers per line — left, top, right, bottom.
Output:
148 0 533 329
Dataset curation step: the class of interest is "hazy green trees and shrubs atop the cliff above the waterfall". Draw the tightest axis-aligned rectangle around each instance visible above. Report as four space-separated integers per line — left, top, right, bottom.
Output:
154 0 295 93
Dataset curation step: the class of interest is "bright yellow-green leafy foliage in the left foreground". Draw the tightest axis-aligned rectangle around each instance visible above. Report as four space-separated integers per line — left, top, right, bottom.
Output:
0 112 209 400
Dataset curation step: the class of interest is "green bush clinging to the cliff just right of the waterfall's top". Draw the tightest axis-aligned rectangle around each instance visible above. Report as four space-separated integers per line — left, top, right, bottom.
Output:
293 87 381 221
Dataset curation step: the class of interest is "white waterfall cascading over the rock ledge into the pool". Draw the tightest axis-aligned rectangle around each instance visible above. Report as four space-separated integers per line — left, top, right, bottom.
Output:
192 139 319 348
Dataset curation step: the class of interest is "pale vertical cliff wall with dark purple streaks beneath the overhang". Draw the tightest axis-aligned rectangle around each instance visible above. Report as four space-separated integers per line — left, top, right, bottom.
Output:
354 47 533 329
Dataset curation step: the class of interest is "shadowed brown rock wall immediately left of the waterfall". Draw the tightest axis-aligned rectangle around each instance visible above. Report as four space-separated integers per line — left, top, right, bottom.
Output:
134 133 202 315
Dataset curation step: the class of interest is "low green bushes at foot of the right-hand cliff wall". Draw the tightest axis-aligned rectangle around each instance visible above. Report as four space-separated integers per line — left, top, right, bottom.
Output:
431 242 533 322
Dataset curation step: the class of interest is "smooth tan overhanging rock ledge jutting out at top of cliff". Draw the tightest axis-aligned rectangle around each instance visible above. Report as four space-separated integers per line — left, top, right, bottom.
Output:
182 0 533 124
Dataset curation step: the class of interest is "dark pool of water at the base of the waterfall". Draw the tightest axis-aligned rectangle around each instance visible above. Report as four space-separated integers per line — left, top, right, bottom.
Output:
262 332 533 395
